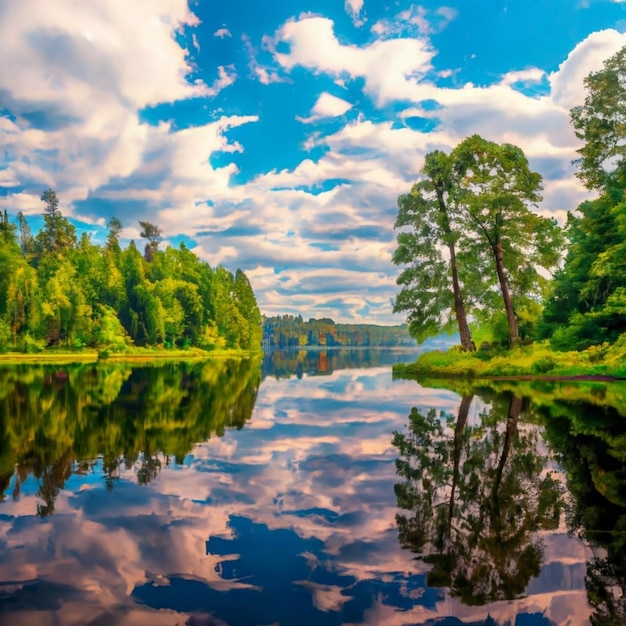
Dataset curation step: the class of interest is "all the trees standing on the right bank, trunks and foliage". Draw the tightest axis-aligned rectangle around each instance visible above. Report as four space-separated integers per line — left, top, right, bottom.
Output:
393 47 626 351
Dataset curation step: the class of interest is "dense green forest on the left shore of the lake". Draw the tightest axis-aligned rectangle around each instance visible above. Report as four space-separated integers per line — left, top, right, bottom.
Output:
0 189 262 352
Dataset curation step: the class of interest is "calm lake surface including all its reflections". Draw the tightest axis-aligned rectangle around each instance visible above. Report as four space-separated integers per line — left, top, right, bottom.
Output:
0 351 626 626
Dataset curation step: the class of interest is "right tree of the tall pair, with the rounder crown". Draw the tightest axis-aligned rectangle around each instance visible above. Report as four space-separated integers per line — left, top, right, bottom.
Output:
452 135 563 345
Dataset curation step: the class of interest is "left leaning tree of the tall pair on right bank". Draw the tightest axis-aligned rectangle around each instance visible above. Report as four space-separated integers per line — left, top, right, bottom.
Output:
393 150 475 351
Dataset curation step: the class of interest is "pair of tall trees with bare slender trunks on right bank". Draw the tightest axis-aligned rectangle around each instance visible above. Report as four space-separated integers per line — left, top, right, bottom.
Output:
393 135 564 351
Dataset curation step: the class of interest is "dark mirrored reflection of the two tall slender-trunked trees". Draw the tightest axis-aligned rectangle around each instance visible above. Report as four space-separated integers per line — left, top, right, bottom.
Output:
393 395 563 605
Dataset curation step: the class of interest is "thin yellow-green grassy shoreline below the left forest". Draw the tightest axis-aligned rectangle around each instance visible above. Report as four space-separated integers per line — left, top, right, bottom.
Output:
0 348 262 366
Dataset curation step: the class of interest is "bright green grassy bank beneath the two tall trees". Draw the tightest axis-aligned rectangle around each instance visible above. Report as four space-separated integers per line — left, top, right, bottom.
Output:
394 336 626 379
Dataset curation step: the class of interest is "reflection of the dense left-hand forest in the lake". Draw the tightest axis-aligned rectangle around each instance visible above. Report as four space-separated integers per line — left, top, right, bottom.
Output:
0 360 261 517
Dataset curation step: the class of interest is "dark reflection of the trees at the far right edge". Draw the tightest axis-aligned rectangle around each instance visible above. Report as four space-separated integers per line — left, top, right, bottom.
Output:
542 394 626 626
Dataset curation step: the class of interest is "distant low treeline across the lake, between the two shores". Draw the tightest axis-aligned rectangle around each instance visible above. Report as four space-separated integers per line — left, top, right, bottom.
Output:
263 315 416 349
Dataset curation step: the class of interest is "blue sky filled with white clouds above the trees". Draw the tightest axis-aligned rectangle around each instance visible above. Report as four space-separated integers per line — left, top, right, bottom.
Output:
0 0 626 324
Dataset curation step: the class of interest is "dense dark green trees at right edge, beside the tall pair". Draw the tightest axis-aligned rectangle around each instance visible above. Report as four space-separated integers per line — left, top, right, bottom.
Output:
540 47 626 350
